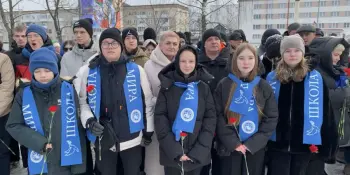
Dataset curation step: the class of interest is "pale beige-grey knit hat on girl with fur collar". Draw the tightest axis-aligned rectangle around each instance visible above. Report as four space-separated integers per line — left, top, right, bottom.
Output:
280 35 305 55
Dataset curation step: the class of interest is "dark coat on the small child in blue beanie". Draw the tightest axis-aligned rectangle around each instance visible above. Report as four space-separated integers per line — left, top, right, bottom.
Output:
6 80 86 175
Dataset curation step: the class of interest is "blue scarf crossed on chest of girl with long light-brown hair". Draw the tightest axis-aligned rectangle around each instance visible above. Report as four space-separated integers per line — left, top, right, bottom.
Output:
228 73 260 141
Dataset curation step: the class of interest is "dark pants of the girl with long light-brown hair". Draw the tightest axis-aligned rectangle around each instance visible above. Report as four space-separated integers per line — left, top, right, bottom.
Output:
220 149 265 175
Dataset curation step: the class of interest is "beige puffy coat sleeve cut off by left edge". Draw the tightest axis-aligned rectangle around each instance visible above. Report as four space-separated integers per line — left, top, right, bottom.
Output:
0 53 15 117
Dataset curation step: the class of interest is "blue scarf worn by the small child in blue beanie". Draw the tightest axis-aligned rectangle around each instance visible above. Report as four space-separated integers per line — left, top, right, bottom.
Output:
22 82 82 175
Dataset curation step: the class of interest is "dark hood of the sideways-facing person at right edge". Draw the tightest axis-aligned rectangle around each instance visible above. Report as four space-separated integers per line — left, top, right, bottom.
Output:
309 37 350 76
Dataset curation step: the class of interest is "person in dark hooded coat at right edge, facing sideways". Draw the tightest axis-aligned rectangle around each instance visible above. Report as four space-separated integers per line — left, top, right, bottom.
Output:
307 37 350 175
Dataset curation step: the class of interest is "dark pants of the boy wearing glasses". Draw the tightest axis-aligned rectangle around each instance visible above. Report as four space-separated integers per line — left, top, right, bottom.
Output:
95 146 142 175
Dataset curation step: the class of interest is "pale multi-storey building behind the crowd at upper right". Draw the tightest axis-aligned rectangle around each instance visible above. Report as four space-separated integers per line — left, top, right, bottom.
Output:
238 0 350 44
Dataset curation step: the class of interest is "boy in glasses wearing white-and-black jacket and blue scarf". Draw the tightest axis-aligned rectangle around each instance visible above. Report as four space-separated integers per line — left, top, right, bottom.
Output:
74 28 154 175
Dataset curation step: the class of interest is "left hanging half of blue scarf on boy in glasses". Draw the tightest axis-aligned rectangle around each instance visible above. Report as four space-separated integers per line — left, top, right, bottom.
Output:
86 67 101 143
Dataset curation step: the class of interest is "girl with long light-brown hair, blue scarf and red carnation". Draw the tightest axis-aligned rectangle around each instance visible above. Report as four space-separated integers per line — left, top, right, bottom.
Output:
214 43 278 175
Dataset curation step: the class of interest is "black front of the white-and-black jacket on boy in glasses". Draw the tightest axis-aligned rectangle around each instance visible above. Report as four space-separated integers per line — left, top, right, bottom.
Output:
89 55 152 146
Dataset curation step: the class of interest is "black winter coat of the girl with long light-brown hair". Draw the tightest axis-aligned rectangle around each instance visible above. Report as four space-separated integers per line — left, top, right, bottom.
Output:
214 77 278 156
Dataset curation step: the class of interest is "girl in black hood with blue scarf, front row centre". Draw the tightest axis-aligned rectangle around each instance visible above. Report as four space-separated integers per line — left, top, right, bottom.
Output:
154 46 216 175
